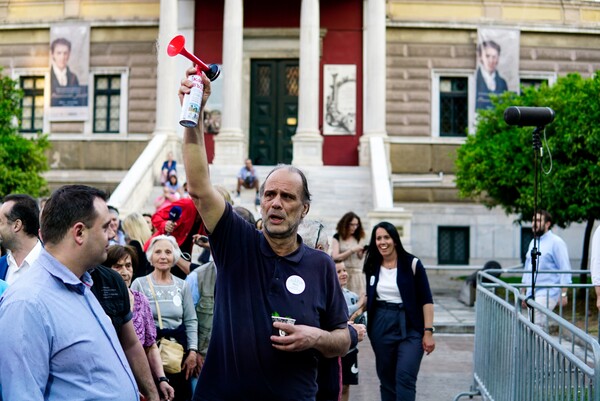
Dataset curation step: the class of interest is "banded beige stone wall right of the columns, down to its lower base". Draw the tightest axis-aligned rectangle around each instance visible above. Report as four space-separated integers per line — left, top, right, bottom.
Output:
386 27 600 202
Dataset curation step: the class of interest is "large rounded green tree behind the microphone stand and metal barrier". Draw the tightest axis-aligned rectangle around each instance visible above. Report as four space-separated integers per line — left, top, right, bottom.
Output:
456 74 600 269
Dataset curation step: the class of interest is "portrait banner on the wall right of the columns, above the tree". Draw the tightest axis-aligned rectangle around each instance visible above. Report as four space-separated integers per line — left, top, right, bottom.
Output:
475 29 520 110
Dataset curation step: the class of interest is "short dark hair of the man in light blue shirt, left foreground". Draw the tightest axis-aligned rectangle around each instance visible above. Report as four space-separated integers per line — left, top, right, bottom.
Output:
41 185 106 244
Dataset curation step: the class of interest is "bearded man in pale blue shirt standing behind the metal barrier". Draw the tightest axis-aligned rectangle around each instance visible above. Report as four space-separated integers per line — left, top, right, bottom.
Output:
522 210 571 329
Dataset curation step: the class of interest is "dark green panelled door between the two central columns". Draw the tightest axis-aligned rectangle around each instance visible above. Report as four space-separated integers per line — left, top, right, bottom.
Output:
250 59 299 165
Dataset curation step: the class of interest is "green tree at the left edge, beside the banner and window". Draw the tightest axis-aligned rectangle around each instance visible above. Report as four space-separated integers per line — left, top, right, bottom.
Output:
0 69 50 197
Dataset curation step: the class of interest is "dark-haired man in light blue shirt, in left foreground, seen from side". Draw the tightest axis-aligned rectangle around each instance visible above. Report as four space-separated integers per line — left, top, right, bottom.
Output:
0 185 139 401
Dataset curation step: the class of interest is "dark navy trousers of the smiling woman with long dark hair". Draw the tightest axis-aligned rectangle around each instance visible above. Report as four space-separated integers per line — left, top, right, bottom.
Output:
369 302 423 401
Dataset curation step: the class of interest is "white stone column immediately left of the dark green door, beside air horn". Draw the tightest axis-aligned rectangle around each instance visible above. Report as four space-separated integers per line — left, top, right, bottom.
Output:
213 0 248 165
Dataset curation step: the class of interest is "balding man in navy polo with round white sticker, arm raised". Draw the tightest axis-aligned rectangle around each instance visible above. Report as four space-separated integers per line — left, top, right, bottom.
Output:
179 69 350 401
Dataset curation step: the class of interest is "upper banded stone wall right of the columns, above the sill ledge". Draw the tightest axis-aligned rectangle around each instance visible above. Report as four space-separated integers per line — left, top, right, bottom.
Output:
387 28 600 142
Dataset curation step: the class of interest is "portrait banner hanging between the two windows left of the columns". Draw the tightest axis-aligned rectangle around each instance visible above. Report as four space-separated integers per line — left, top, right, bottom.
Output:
50 25 90 121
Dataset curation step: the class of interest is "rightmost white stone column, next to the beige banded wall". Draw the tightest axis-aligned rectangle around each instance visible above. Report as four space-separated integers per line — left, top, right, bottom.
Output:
359 0 389 166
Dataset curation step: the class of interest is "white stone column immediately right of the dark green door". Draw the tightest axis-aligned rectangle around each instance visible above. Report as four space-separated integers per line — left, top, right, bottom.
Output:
292 0 323 166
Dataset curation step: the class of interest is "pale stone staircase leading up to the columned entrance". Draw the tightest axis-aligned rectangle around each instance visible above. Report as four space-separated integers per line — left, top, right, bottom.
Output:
143 165 373 231
